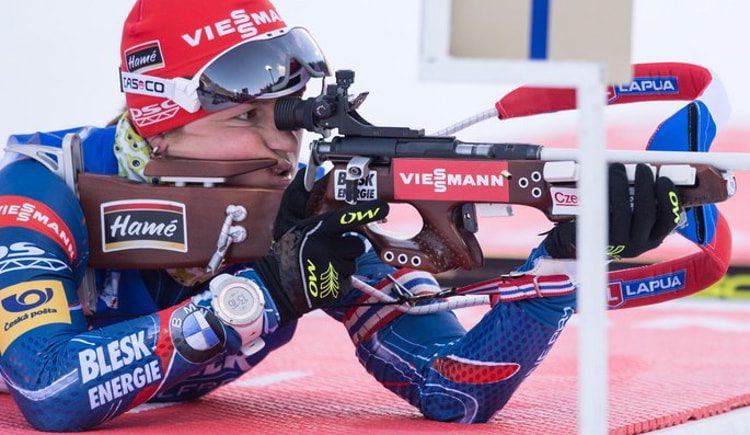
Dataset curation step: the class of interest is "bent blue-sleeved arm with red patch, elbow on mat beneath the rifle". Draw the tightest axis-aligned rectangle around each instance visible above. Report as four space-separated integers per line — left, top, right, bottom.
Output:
330 250 575 423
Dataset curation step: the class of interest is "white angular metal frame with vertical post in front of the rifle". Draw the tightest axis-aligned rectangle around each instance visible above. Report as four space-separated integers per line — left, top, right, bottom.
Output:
420 0 608 434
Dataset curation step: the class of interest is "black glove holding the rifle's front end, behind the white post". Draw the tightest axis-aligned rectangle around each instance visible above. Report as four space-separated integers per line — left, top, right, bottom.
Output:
544 163 680 258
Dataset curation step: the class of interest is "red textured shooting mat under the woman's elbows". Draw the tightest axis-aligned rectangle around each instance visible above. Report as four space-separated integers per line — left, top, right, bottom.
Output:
0 302 750 434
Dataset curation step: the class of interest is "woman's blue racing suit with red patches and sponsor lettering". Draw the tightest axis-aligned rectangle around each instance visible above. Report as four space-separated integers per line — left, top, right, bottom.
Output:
0 128 575 431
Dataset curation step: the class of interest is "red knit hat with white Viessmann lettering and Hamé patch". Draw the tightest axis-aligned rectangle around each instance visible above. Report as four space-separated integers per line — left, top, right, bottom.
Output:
120 0 296 137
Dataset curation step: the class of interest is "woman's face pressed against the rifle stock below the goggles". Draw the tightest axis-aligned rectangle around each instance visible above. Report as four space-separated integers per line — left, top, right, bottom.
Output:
149 100 302 189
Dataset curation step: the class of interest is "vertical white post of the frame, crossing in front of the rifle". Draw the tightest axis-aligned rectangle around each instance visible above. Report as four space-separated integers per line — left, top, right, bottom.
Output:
576 64 608 435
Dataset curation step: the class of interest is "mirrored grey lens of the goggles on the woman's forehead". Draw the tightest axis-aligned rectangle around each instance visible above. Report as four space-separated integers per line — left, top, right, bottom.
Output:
197 27 329 111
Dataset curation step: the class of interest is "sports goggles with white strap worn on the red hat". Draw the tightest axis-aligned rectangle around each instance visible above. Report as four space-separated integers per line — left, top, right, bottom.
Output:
120 27 329 113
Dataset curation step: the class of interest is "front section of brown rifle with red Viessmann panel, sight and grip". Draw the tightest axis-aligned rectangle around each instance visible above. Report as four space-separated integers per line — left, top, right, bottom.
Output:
274 70 747 273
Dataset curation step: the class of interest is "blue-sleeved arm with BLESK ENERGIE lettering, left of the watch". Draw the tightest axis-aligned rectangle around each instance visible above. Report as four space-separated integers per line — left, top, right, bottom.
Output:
0 160 253 431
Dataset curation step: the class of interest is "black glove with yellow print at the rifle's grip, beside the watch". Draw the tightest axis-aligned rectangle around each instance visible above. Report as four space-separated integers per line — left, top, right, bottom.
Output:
255 173 389 324
